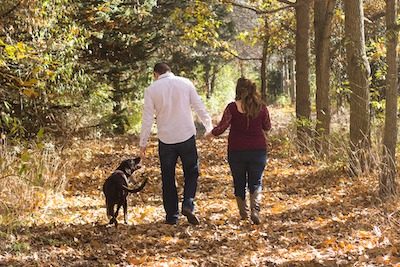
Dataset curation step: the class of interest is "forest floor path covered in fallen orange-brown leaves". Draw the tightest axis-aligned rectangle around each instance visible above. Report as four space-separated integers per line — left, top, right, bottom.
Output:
0 110 400 266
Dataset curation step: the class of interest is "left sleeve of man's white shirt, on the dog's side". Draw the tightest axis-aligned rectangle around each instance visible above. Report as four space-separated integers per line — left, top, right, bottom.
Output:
139 89 154 147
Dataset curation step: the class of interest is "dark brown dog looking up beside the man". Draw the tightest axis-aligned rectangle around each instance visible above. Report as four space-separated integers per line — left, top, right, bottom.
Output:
103 158 147 227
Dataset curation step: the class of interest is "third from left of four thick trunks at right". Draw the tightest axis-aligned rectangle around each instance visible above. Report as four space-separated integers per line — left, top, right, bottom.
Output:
344 0 371 175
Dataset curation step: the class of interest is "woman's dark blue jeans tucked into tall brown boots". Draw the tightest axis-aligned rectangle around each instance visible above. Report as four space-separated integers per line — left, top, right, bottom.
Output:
228 150 267 199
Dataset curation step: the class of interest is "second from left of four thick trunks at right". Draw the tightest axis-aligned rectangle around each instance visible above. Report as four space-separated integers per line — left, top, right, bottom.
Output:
314 0 335 153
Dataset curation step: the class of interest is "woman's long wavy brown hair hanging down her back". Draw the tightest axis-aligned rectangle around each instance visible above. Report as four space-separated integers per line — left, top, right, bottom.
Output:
235 77 263 118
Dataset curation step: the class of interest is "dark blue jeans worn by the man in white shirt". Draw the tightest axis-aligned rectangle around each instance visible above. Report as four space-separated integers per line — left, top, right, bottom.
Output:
158 136 199 221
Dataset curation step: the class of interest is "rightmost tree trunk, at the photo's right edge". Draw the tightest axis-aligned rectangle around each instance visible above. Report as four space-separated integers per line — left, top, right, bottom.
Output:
379 0 398 197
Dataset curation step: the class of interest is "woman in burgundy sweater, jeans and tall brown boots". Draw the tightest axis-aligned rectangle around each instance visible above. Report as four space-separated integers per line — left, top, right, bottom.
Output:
206 78 271 224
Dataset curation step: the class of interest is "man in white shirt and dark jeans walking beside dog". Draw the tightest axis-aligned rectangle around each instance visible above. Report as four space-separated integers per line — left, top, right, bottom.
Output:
139 63 212 225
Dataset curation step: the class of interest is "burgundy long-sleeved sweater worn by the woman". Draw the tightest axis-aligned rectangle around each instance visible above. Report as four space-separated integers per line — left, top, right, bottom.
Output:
211 102 271 151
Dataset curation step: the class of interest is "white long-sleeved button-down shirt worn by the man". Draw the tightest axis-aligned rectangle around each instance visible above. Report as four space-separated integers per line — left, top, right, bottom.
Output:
139 72 212 147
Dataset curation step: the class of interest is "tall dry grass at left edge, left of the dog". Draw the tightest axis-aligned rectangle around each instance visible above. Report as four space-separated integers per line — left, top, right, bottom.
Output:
0 139 66 225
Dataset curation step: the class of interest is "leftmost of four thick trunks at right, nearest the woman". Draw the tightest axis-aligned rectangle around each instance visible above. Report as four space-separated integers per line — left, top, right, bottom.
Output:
296 0 311 150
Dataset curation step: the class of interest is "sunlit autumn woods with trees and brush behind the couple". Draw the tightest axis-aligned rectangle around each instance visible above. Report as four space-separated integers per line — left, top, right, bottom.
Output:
0 0 400 266
